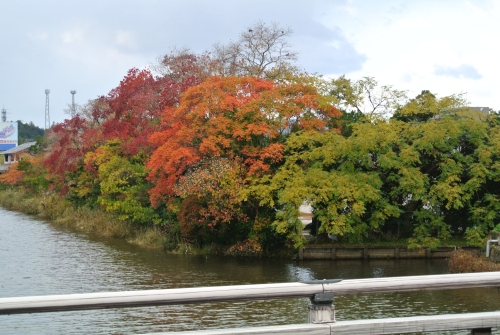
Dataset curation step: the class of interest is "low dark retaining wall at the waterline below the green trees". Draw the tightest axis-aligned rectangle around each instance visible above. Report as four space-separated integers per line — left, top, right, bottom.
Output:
299 246 479 259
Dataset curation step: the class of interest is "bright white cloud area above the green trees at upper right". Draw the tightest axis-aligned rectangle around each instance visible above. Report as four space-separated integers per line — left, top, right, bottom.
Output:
332 0 500 109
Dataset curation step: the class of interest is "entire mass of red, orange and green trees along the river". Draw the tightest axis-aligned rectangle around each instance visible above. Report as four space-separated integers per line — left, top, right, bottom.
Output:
0 22 500 254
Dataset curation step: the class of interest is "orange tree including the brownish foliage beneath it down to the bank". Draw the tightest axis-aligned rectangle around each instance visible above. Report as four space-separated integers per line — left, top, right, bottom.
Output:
143 77 340 249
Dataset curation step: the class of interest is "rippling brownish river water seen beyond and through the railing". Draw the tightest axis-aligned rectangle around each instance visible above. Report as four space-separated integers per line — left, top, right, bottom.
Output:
0 209 500 334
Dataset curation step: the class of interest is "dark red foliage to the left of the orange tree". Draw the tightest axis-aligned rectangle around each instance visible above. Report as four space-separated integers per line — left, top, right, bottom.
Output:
45 69 199 193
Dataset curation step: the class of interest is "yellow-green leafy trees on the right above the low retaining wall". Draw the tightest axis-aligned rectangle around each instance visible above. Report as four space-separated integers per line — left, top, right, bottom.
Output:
251 95 500 247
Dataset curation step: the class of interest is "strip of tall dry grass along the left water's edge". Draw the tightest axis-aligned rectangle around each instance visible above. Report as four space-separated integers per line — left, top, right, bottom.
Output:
0 189 165 248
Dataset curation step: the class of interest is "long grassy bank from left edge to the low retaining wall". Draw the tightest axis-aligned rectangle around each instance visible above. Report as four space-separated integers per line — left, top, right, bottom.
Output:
0 189 293 258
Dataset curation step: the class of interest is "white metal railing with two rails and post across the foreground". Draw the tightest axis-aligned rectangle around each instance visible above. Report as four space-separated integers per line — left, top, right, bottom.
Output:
0 272 500 334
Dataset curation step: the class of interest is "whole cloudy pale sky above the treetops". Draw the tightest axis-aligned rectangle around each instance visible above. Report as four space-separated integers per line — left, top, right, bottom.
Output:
0 0 500 127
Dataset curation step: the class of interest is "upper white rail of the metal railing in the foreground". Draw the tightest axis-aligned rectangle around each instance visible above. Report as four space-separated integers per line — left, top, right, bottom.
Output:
0 272 500 315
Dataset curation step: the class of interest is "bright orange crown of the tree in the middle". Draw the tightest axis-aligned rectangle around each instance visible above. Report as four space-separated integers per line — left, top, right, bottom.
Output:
147 77 340 244
